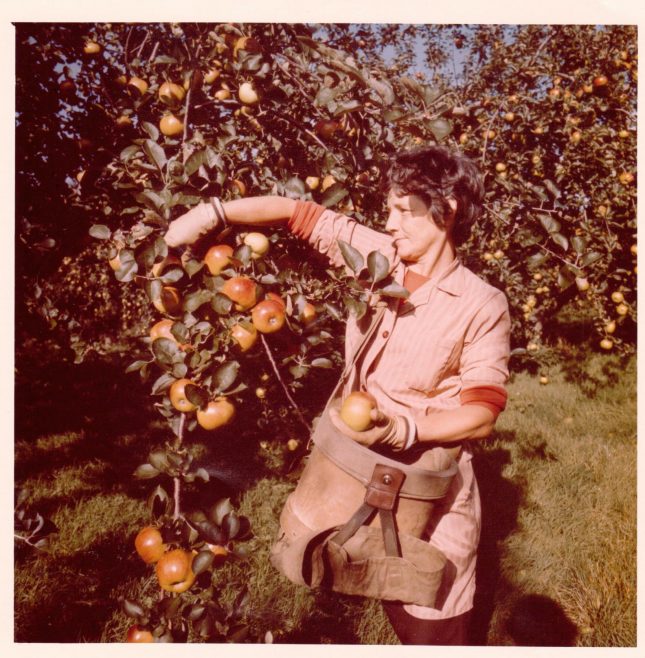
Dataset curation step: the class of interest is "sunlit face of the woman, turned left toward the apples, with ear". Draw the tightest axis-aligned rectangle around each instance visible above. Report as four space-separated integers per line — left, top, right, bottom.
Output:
385 191 457 263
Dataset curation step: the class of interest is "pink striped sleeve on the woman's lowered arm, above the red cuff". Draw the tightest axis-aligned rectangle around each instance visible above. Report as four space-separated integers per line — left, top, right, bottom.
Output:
459 291 511 390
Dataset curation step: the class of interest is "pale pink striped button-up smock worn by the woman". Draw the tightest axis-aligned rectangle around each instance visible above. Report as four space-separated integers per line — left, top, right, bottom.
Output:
290 204 510 619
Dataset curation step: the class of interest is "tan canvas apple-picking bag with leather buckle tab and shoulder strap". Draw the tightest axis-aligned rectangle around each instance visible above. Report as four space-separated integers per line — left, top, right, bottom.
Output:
271 300 459 606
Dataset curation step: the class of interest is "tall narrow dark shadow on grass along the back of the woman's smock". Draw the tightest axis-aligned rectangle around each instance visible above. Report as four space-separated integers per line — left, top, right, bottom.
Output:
471 432 522 646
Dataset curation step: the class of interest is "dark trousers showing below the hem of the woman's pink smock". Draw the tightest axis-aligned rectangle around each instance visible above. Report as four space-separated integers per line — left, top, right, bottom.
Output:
382 601 472 646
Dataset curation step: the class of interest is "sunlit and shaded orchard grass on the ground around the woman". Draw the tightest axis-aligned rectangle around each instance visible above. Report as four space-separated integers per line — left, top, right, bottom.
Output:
14 348 636 647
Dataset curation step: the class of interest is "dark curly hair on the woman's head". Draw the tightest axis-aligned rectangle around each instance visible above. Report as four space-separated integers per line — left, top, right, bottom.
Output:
387 145 484 244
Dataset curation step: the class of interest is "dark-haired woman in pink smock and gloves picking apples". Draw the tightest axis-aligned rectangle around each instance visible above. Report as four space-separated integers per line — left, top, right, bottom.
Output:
166 146 510 645
